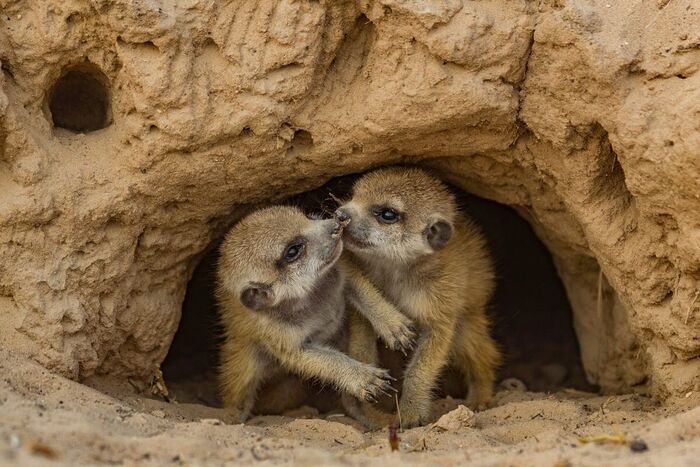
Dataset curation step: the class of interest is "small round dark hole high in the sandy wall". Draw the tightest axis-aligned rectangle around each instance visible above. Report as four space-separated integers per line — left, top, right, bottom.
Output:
47 63 112 133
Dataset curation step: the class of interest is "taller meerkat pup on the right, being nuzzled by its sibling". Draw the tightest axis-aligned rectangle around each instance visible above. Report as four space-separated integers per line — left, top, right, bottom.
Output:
336 167 500 427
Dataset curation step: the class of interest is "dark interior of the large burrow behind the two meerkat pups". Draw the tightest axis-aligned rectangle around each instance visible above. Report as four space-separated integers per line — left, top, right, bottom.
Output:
162 171 596 410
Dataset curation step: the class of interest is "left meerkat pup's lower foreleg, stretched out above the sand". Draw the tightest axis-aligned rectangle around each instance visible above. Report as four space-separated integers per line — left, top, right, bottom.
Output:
266 343 395 402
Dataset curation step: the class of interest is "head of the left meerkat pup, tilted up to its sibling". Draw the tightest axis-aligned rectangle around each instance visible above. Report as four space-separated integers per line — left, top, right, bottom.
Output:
218 206 343 310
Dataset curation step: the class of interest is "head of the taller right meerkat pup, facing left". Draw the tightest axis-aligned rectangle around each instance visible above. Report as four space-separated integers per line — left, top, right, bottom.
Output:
336 167 457 262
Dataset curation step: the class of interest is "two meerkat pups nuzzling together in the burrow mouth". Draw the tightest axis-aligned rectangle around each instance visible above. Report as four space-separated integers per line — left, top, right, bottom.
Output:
218 167 499 428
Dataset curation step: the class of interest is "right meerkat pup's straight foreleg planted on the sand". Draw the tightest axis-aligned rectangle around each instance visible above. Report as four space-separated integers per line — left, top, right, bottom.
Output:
399 322 455 428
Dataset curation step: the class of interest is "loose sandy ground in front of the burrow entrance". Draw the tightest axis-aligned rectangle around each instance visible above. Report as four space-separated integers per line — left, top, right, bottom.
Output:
0 350 700 467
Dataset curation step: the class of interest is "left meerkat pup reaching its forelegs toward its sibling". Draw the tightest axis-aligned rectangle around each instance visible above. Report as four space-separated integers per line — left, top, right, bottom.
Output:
217 206 413 421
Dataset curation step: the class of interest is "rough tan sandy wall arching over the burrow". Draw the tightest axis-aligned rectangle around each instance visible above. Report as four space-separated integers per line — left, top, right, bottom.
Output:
0 0 700 399
